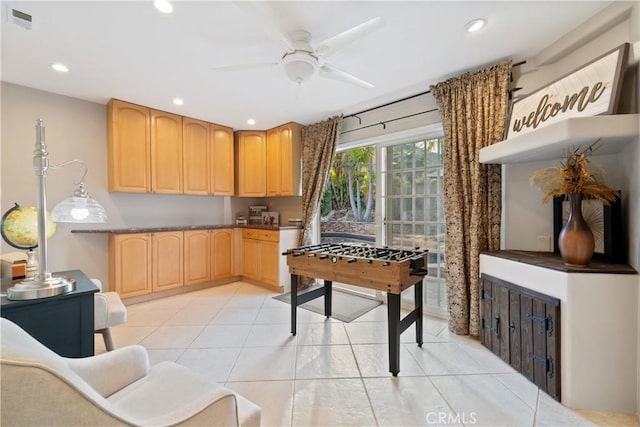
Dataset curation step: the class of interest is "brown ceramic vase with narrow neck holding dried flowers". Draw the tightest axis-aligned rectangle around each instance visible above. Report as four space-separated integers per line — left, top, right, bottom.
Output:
558 193 595 267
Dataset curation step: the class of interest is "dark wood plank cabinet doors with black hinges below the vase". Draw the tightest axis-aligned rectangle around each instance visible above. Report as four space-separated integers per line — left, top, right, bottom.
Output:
480 274 560 401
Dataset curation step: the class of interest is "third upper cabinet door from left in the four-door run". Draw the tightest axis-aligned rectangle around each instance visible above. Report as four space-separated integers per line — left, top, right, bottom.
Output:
182 117 211 195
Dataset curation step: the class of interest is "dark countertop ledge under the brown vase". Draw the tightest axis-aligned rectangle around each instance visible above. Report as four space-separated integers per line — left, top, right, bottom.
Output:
482 250 637 274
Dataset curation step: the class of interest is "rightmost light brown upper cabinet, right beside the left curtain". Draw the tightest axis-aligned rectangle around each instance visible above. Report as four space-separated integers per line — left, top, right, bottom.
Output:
267 123 302 196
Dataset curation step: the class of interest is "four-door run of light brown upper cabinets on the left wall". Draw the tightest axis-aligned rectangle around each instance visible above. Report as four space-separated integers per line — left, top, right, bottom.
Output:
107 99 235 196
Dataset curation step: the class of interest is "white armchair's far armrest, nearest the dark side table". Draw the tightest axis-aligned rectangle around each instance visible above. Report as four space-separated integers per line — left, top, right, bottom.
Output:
65 345 149 397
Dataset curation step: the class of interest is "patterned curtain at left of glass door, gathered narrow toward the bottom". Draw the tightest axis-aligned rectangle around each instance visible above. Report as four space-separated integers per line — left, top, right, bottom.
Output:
299 116 342 249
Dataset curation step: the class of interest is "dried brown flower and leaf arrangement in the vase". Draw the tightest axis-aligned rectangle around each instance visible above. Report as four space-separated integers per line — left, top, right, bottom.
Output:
530 140 618 205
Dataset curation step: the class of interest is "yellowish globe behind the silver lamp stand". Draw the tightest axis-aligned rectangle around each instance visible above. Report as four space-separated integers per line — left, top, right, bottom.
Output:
0 203 56 250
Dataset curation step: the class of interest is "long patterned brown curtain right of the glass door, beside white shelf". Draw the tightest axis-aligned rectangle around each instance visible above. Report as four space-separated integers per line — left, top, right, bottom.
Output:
431 61 511 336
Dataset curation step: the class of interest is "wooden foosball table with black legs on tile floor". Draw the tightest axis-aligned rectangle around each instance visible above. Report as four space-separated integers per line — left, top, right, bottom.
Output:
283 243 428 376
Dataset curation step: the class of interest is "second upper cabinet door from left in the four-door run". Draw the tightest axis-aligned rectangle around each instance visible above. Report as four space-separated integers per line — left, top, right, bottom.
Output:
151 110 183 194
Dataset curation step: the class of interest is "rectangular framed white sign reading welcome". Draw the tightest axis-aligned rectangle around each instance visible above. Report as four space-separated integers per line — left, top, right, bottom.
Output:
507 43 629 137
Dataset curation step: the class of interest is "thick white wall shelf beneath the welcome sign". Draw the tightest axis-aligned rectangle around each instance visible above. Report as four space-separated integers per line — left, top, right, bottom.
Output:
480 114 640 164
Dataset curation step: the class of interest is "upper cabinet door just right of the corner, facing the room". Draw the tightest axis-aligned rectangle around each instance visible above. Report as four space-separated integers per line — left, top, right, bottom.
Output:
236 131 267 197
